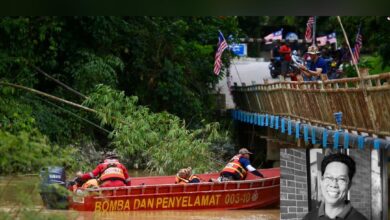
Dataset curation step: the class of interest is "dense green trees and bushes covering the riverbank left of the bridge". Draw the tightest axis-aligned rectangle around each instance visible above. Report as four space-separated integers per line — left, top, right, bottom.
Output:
0 17 239 174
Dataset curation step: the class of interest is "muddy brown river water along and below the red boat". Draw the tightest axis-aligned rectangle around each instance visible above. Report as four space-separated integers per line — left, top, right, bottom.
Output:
0 171 280 220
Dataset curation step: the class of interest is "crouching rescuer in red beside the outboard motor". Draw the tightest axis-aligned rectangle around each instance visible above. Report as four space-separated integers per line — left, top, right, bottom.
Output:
78 152 131 187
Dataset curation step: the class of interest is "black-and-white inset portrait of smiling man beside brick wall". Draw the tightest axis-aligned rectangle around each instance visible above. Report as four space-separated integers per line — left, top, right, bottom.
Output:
280 148 388 220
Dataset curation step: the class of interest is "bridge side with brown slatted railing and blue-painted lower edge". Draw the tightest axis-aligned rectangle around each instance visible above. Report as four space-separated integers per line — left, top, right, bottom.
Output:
232 73 390 149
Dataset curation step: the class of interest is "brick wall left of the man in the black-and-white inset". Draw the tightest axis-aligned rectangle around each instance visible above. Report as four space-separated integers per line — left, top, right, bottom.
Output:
280 148 309 220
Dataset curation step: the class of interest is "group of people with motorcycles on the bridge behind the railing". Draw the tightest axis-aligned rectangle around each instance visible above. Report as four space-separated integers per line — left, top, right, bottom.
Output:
271 40 351 81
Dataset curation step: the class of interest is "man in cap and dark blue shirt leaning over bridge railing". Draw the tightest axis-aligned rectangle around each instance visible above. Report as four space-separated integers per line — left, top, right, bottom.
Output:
299 45 328 81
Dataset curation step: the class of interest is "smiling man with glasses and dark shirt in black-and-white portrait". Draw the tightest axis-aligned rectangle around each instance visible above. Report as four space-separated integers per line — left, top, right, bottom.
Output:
304 153 367 220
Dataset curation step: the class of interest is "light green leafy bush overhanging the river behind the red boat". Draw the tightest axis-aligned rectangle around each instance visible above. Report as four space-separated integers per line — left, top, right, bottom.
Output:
84 85 226 174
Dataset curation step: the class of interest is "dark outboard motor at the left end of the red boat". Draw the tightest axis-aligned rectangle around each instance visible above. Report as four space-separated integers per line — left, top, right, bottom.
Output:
40 166 68 209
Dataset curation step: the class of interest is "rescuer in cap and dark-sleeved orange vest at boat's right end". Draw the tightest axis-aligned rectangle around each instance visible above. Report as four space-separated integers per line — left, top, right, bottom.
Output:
219 148 264 181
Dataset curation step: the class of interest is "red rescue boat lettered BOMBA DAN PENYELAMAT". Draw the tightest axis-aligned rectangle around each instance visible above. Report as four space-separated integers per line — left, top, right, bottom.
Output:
69 168 280 212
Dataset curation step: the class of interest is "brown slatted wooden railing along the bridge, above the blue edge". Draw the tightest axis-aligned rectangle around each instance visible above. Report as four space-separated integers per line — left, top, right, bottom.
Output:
232 73 390 136
